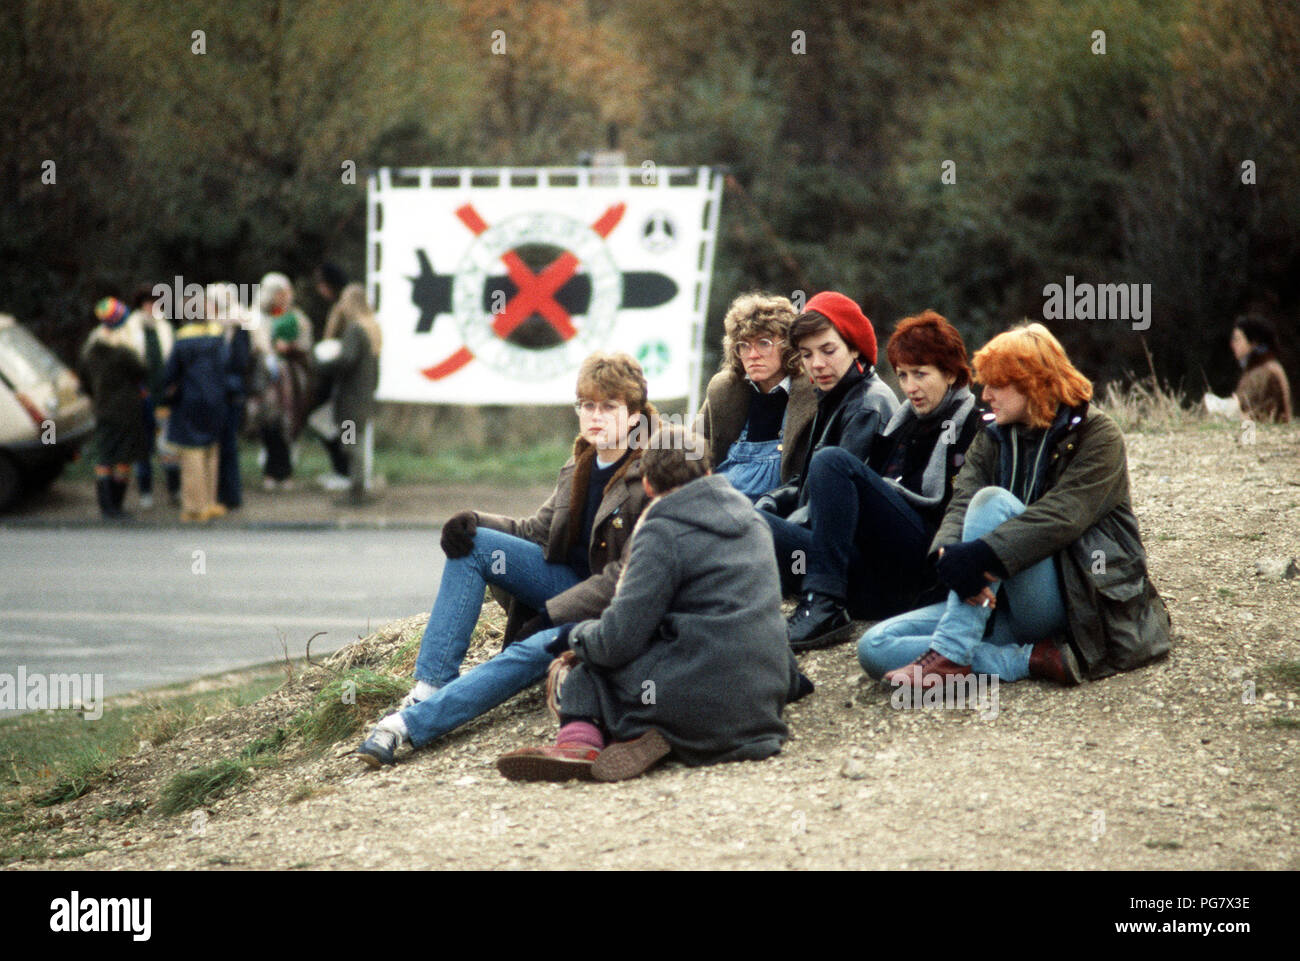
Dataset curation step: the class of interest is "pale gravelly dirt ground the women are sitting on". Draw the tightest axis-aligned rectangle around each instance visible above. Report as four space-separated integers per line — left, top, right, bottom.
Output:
8 425 1300 870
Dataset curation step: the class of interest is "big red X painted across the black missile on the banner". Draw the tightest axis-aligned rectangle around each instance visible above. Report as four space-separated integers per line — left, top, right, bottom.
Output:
421 204 627 380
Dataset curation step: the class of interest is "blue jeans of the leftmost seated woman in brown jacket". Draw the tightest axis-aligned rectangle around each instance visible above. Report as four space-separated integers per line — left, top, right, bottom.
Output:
402 528 581 748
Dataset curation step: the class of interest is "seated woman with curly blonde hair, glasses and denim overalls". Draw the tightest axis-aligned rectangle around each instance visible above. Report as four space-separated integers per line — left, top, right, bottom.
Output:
694 293 816 501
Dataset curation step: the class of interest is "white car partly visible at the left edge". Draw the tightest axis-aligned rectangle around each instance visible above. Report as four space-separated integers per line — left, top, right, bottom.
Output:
0 313 95 510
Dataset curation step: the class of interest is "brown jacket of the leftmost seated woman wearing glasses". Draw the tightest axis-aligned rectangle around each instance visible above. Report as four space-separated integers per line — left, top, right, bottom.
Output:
476 423 649 626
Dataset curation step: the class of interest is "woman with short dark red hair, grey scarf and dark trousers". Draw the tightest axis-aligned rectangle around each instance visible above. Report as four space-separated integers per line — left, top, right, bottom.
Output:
774 311 979 650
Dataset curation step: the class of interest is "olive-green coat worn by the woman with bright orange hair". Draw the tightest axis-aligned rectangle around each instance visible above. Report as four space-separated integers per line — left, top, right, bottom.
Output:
931 403 1170 678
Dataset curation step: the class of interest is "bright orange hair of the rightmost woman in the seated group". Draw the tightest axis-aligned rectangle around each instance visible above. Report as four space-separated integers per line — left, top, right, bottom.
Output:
972 324 1092 428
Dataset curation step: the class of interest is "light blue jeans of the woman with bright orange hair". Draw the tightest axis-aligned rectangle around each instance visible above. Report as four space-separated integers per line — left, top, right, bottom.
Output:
858 488 1067 681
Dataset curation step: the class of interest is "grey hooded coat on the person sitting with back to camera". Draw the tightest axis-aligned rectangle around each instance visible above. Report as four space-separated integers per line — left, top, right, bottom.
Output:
560 475 792 765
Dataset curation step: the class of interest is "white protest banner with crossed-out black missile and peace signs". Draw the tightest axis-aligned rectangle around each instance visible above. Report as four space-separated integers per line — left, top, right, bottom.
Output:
367 166 722 412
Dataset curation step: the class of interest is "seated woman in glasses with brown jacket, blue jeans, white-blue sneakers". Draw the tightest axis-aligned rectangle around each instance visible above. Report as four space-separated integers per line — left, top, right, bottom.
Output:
355 354 658 767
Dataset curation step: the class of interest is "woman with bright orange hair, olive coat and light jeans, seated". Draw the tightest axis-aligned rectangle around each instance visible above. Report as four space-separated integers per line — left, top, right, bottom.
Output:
858 324 1169 688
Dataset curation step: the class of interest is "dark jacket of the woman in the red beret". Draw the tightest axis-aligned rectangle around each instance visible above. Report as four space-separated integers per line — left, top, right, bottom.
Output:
755 364 898 524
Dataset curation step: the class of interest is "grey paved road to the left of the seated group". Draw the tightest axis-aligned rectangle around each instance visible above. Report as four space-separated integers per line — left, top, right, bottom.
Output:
0 528 443 694
